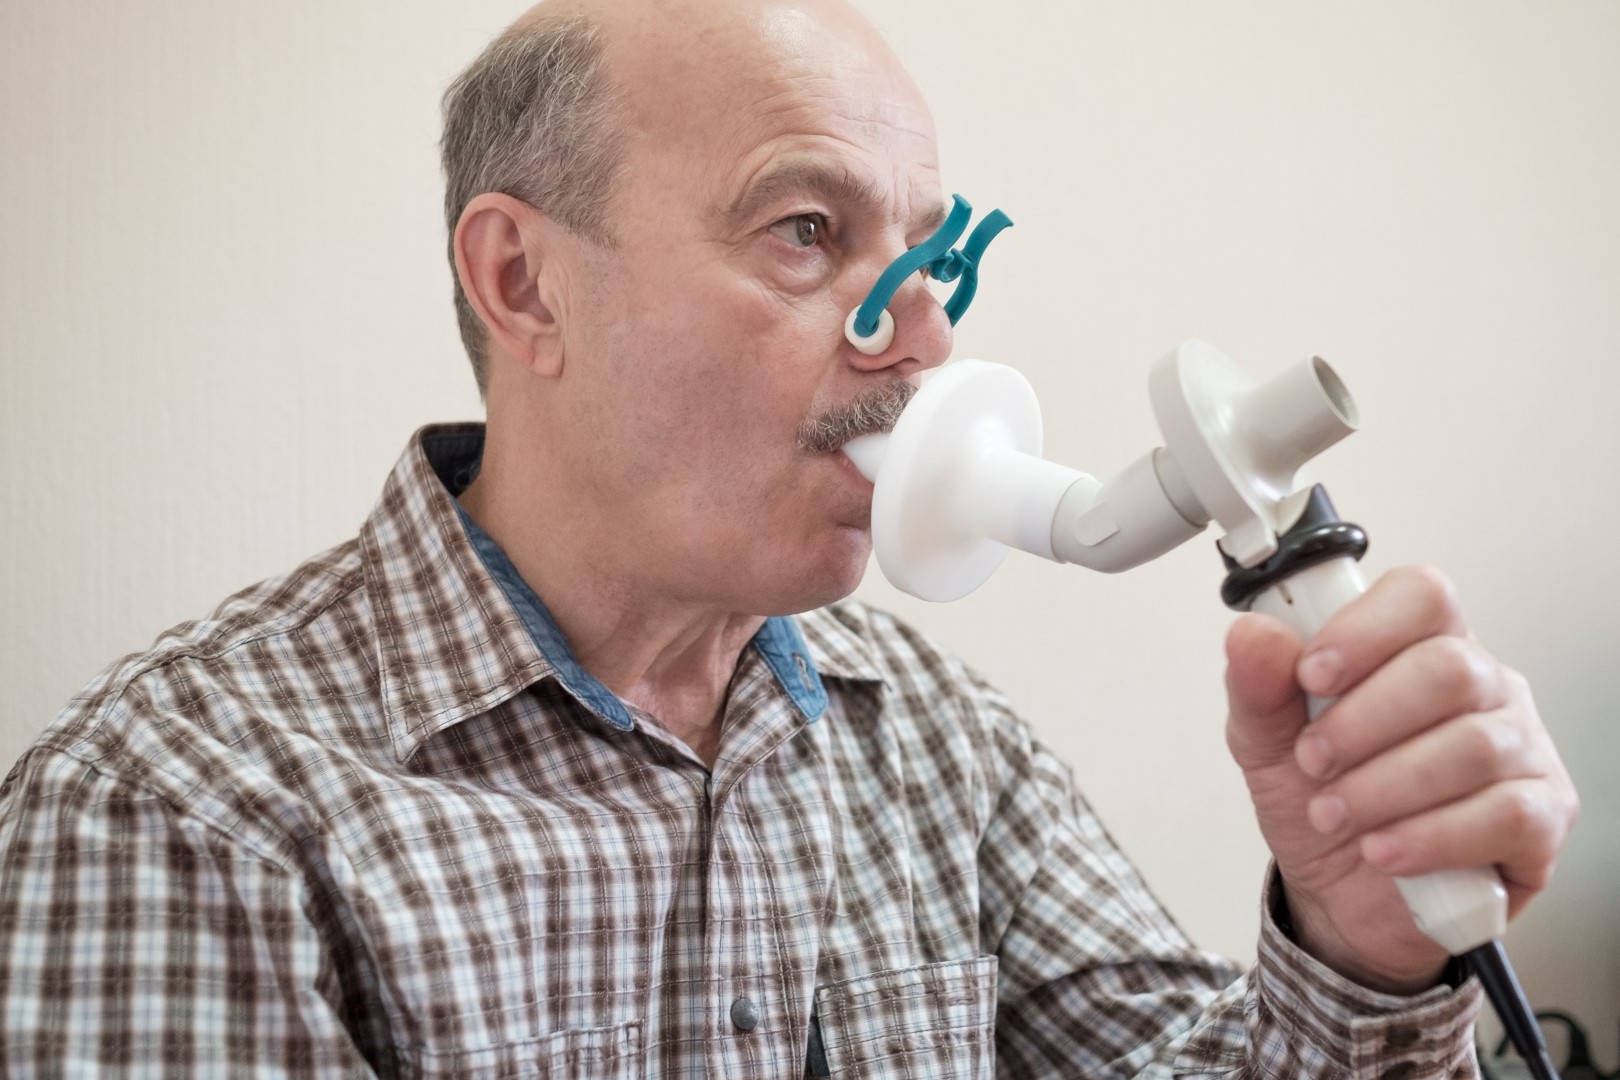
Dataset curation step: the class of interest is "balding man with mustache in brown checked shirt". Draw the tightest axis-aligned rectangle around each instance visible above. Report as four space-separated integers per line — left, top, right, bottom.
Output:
0 0 1575 1077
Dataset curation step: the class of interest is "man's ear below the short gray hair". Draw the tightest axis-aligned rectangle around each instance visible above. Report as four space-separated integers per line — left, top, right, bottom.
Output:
455 191 567 379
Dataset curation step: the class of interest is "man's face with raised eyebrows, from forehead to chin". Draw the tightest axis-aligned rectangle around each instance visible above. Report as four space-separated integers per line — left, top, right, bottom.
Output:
559 10 951 615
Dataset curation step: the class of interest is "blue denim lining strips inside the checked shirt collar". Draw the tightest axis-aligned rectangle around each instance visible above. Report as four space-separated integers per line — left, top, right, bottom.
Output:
455 504 826 730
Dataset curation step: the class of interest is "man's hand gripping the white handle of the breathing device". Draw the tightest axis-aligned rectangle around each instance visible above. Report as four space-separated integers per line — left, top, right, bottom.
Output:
1226 568 1578 993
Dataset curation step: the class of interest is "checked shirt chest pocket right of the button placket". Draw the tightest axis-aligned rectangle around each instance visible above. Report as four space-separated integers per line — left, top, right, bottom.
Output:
815 957 996 1080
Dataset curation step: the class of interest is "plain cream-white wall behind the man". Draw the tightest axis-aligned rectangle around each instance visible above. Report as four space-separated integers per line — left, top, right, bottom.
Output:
0 0 1620 1067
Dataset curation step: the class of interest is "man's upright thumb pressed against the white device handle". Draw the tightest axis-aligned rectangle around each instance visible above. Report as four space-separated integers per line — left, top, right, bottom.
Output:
1226 615 1306 772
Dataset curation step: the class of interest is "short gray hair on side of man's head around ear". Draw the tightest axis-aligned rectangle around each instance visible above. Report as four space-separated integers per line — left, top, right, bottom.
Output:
439 16 622 397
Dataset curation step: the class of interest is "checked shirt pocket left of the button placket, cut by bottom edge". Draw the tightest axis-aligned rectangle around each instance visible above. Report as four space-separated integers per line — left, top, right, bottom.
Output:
402 1020 646 1080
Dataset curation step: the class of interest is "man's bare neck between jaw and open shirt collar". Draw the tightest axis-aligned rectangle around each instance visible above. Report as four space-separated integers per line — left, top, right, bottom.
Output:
460 476 765 767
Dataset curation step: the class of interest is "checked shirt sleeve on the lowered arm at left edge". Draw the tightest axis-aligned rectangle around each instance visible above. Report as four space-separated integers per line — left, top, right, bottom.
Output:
0 750 382 1077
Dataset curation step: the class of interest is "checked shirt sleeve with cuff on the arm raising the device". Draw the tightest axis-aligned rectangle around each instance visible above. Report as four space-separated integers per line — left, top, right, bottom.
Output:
980 680 1479 1080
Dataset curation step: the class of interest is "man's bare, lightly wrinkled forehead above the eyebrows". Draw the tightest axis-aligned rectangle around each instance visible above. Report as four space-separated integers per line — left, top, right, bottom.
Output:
576 0 944 230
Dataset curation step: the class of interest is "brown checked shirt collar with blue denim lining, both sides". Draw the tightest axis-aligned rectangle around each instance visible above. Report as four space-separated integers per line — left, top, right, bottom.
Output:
361 424 883 761
